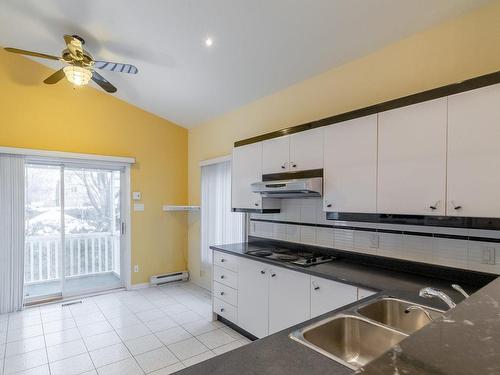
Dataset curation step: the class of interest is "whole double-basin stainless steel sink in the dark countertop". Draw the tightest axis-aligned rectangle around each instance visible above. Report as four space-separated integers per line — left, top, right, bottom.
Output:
290 297 443 370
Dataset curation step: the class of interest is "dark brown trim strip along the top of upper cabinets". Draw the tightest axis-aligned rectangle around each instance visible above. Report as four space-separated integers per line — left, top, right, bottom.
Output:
234 71 500 147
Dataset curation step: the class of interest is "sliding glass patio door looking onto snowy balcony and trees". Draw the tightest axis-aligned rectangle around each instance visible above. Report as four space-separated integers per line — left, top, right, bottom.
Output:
25 164 123 301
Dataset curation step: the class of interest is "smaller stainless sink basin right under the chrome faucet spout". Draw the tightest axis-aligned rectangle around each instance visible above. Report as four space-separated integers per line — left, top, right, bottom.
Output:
357 297 443 334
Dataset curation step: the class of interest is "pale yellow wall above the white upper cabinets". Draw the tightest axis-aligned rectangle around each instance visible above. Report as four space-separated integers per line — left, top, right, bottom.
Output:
189 0 500 285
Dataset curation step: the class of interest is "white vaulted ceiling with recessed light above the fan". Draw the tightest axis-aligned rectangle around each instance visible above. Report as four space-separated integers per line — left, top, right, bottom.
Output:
0 0 488 127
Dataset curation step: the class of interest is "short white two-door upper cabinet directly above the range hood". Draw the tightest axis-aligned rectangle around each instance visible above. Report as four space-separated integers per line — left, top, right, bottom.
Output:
262 128 323 174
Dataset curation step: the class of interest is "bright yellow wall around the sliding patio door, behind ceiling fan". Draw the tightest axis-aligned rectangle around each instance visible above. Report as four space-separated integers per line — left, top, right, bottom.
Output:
0 50 188 284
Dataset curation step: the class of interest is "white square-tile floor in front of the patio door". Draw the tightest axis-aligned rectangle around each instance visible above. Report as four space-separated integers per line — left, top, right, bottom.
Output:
0 283 249 375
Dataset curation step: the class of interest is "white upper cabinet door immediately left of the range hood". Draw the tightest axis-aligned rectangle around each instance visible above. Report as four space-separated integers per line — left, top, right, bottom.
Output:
231 142 262 209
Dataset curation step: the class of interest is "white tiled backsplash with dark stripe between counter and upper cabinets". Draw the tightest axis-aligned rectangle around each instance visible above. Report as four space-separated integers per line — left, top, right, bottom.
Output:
250 198 500 274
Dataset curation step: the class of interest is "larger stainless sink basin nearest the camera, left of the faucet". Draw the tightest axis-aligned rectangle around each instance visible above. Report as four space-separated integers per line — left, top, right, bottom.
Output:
290 315 407 370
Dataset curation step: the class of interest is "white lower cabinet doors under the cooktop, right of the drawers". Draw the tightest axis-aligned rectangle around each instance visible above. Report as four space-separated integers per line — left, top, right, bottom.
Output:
232 258 366 338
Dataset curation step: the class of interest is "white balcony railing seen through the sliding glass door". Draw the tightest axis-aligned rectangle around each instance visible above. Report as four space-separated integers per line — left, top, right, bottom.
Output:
24 232 120 285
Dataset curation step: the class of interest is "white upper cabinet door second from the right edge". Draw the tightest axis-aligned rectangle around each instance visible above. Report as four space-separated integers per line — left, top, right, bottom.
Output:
377 98 447 215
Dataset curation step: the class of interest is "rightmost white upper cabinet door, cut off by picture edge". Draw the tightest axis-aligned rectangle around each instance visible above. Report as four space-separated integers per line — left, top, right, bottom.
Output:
447 85 500 217
